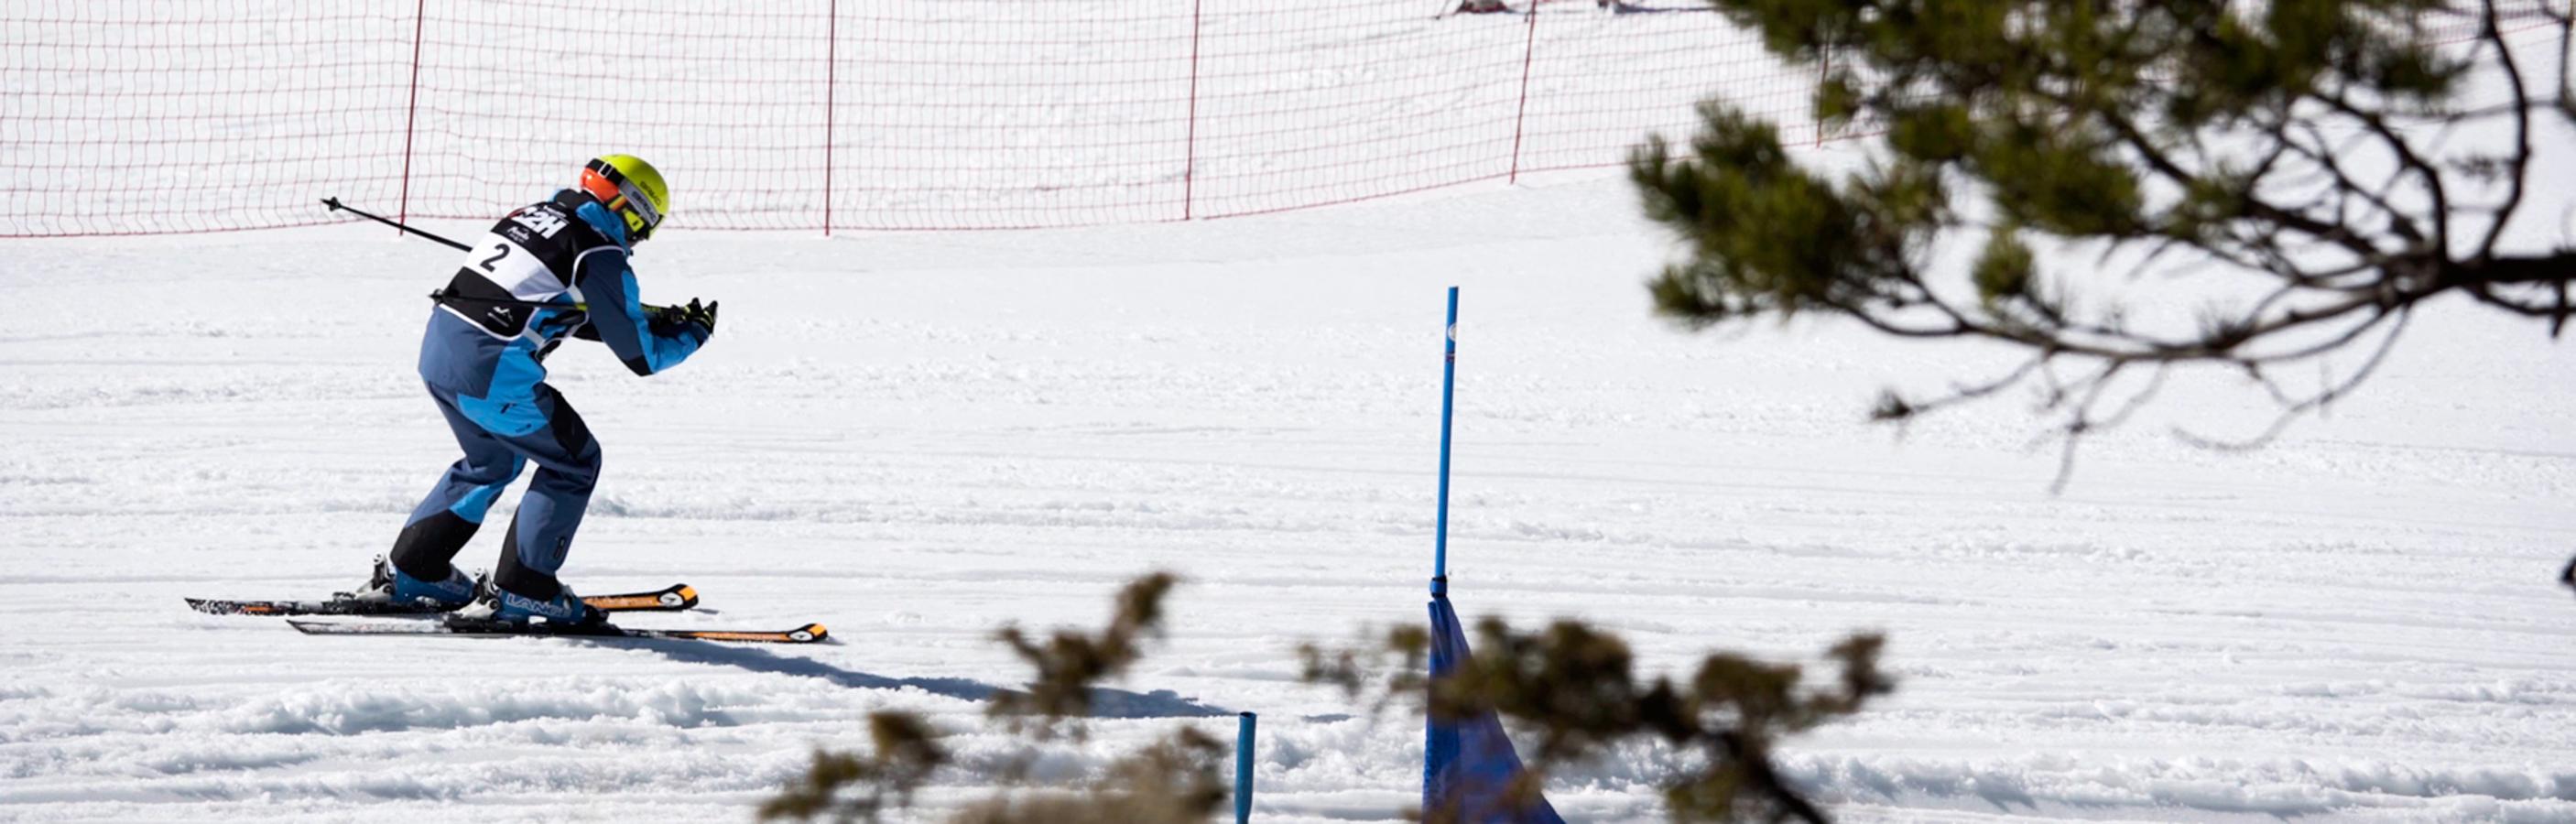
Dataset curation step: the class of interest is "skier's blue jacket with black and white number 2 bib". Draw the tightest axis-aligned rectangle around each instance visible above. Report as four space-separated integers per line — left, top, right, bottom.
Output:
420 188 706 435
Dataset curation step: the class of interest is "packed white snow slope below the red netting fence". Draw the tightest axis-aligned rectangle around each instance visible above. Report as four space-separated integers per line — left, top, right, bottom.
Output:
0 183 2576 821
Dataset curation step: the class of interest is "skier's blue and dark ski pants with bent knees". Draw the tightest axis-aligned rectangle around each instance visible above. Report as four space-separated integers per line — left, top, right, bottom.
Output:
392 384 600 600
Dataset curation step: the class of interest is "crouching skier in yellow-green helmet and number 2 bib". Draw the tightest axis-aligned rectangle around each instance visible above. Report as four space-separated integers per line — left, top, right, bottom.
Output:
355 155 716 623
